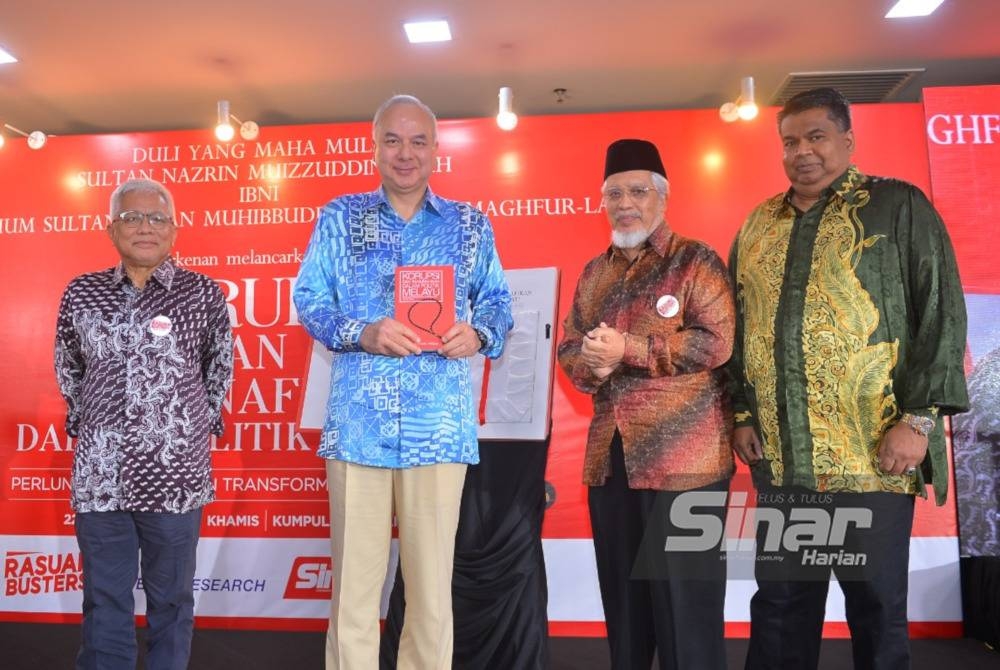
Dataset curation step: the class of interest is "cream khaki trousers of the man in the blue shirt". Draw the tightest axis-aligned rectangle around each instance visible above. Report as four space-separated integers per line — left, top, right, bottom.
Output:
326 460 466 670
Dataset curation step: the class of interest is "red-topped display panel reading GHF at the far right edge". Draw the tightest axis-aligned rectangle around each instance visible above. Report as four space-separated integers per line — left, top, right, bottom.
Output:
924 86 1000 556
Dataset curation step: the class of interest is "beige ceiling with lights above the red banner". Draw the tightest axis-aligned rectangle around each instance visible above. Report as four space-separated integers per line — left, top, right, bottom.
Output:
0 0 1000 134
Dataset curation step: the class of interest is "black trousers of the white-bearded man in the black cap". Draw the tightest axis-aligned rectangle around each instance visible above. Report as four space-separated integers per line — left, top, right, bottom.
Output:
588 432 729 670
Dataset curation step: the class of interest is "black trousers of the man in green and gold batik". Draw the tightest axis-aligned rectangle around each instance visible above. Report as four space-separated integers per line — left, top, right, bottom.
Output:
746 487 913 670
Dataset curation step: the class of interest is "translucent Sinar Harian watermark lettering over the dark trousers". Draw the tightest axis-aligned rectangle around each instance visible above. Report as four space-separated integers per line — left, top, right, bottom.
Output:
663 491 872 566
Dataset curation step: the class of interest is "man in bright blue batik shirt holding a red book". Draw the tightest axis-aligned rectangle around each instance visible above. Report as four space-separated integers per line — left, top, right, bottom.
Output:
294 95 513 670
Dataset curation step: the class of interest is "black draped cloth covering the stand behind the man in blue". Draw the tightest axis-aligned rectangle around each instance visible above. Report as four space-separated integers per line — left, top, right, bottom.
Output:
379 440 549 670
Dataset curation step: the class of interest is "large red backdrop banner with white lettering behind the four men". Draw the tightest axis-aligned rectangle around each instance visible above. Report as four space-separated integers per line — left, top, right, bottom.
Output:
0 104 968 632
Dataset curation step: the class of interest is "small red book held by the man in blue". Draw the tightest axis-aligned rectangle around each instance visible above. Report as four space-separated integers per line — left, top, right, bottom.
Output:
396 265 455 351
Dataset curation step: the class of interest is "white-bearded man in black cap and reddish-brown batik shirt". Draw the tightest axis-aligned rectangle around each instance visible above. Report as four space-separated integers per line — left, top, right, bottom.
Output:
559 139 734 670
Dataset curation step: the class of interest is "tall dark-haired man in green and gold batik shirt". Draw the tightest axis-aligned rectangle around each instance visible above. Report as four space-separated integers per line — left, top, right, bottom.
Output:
729 88 968 670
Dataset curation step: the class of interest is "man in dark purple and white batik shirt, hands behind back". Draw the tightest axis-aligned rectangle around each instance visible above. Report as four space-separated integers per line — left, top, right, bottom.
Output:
55 180 233 670
